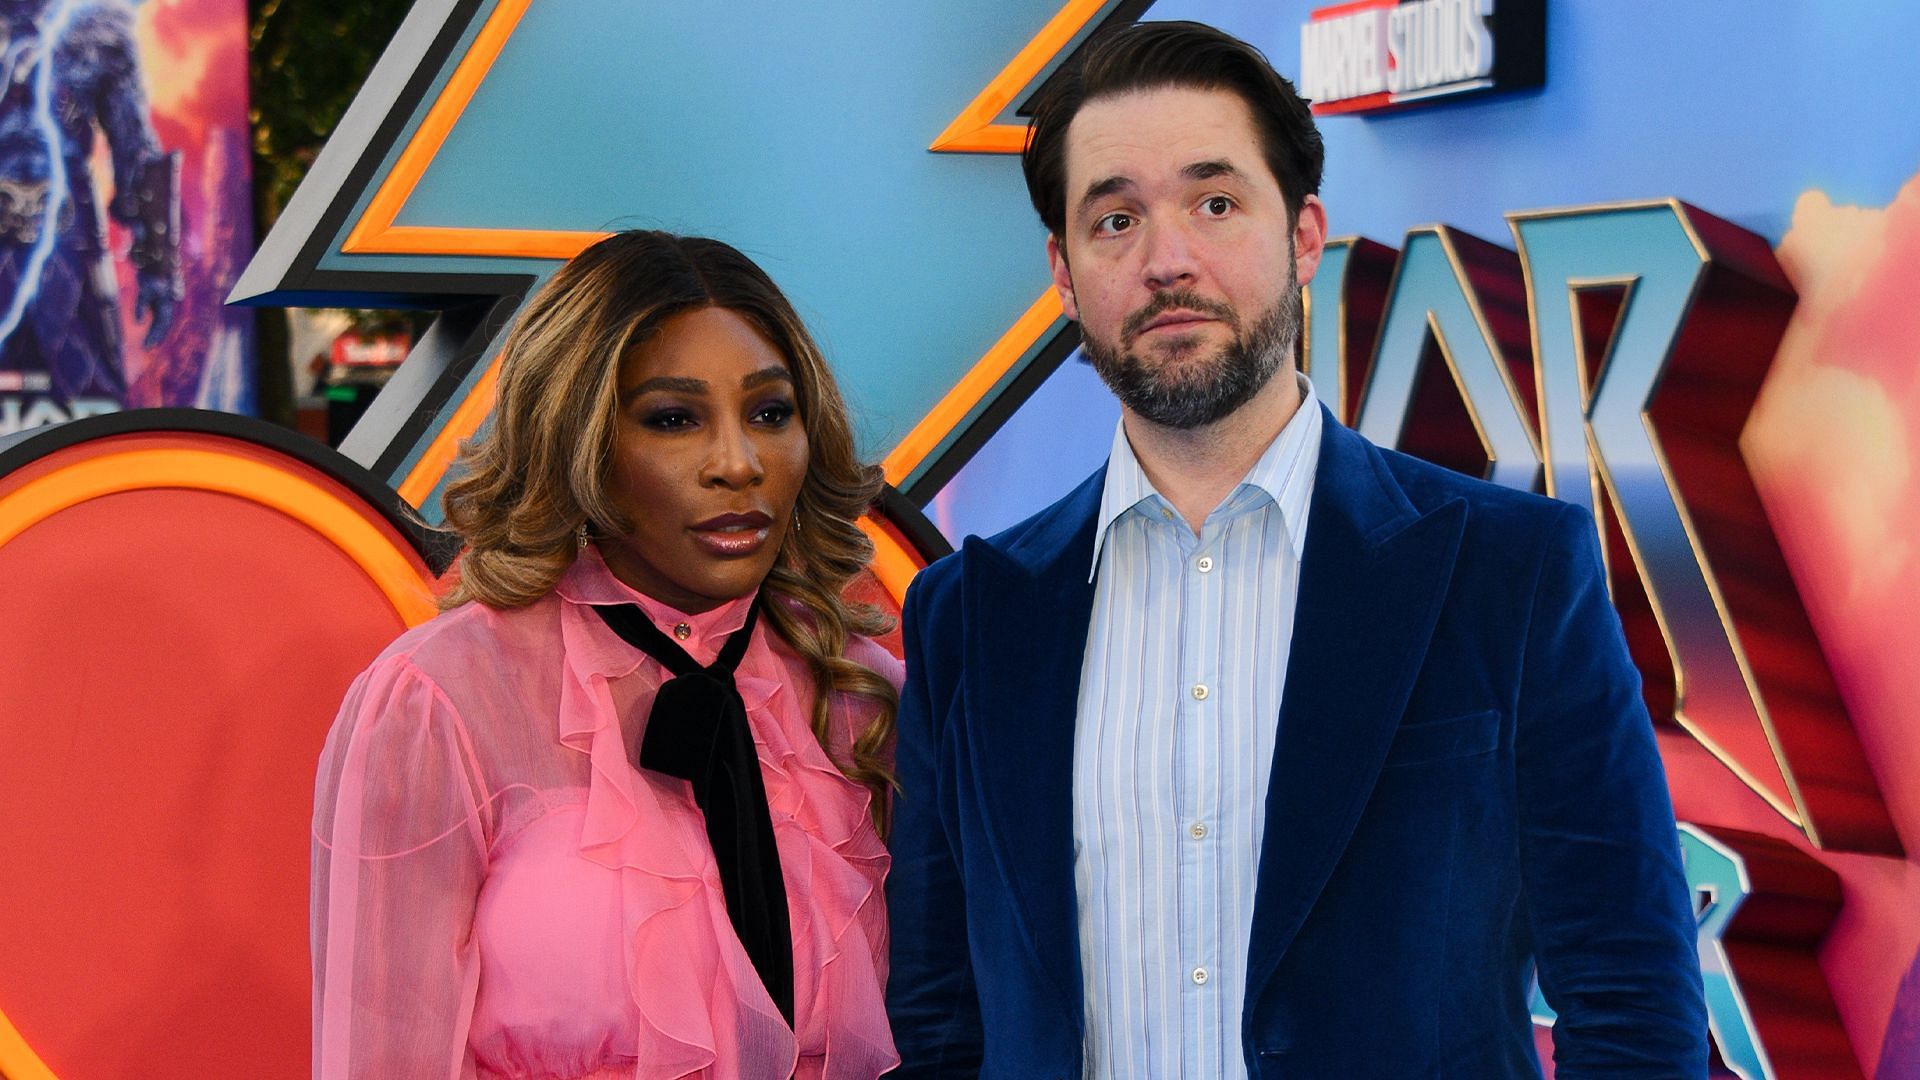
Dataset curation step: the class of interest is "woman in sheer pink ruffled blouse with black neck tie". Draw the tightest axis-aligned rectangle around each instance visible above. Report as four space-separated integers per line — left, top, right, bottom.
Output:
313 233 900 1078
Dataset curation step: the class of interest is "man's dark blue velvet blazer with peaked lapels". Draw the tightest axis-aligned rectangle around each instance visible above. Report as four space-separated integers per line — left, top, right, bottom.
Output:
887 407 1707 1080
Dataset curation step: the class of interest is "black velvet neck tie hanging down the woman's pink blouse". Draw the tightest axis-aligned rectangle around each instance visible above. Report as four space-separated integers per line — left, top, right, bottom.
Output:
593 598 793 1026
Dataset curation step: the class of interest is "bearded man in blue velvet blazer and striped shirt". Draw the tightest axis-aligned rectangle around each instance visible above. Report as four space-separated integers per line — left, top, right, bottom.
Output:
889 23 1707 1080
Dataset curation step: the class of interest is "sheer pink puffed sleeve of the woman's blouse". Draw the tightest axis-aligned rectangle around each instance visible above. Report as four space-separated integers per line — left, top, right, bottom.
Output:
311 655 488 1080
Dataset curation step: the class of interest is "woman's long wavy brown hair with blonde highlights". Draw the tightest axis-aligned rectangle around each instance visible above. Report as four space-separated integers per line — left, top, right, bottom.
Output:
442 231 899 834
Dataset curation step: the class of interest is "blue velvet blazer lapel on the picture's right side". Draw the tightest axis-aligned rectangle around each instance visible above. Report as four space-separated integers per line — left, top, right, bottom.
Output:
1246 415 1467 1011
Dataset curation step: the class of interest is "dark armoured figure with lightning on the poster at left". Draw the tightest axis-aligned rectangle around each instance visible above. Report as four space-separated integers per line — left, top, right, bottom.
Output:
0 0 182 402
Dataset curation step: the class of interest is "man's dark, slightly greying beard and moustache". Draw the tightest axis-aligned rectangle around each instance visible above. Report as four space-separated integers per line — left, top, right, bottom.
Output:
1081 255 1300 430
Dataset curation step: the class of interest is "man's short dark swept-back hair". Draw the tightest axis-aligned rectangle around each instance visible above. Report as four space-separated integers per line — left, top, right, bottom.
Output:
1020 23 1325 236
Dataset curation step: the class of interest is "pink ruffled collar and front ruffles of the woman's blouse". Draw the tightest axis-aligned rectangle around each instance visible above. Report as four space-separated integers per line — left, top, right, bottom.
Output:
555 548 899 1078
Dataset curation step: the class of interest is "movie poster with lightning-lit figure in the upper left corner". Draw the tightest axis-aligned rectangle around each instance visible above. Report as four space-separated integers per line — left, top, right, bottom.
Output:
0 0 253 436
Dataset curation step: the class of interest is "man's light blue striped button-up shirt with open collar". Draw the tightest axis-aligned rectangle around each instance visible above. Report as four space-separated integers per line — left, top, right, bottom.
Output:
1073 377 1321 1080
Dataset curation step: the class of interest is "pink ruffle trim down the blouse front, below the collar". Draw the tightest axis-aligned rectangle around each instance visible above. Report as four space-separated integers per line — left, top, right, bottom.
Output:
561 611 899 1080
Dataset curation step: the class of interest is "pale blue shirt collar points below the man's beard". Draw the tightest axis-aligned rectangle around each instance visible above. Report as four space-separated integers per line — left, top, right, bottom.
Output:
1087 373 1321 580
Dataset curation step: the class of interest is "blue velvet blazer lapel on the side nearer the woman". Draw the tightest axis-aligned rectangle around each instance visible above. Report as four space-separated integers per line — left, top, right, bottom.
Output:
962 469 1106 1026
